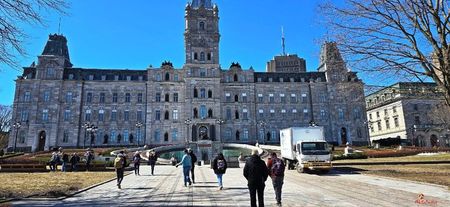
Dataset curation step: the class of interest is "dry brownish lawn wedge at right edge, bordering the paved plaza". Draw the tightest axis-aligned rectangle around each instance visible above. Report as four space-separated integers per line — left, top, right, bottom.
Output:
351 164 450 190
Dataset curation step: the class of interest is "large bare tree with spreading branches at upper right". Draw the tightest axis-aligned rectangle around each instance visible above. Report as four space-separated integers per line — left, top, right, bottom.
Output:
319 0 450 106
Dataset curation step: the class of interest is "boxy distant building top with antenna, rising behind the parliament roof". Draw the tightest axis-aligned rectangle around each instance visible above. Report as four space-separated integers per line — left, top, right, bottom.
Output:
266 55 306 73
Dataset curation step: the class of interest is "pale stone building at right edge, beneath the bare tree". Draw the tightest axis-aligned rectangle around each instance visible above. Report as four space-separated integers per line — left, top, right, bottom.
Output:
366 82 450 147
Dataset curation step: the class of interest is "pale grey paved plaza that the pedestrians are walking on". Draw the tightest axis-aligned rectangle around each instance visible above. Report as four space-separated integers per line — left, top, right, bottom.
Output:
9 166 450 207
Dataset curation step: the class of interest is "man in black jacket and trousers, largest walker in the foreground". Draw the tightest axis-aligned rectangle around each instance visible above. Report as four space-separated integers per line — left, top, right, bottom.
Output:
244 150 269 207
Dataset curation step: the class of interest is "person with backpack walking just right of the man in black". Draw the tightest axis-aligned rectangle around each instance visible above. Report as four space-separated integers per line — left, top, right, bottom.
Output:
267 152 286 206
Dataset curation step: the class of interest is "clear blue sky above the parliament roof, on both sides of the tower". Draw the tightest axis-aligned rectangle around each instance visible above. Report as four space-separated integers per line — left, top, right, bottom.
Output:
0 0 364 105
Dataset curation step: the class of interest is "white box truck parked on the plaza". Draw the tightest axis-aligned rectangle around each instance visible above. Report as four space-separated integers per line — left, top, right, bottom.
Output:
280 126 332 173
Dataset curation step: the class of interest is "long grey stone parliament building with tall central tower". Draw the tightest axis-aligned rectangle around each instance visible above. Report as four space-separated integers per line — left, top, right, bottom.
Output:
9 0 369 151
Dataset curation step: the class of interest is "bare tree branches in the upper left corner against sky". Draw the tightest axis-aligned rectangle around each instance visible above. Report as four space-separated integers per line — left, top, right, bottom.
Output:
0 0 68 68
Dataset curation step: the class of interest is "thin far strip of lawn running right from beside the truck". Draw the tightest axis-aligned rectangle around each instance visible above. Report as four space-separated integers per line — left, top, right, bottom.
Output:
333 153 450 163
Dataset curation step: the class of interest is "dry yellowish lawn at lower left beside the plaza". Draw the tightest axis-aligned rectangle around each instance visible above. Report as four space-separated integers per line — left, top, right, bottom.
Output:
0 172 115 198
